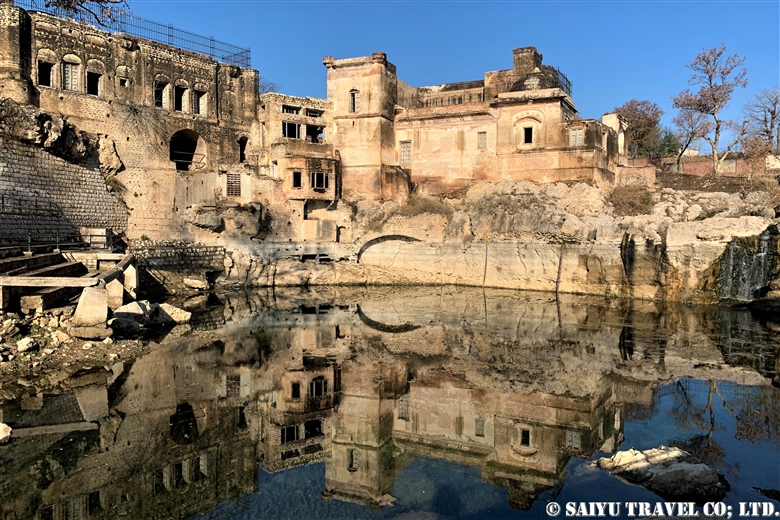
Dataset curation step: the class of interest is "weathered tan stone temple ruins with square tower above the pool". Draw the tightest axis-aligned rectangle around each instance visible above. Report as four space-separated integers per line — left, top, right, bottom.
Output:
0 0 625 248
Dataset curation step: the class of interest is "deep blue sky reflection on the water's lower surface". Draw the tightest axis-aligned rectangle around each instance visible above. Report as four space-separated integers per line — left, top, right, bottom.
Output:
195 380 780 520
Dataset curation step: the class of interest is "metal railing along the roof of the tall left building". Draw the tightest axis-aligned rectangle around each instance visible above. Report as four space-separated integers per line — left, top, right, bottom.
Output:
15 0 252 67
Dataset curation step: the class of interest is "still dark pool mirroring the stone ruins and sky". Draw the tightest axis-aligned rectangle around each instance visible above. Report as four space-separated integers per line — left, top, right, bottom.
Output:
0 287 780 520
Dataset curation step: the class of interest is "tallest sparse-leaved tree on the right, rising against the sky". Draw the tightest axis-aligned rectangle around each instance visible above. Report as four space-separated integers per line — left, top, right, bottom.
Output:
672 45 747 174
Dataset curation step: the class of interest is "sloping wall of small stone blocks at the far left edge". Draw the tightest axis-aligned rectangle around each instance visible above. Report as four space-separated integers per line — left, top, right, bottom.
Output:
0 138 127 241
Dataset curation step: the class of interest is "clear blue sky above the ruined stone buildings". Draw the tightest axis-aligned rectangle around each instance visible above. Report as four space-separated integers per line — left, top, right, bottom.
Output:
129 0 780 140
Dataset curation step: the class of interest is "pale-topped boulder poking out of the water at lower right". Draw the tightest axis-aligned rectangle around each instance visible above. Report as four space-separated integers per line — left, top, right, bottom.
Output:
591 446 731 505
